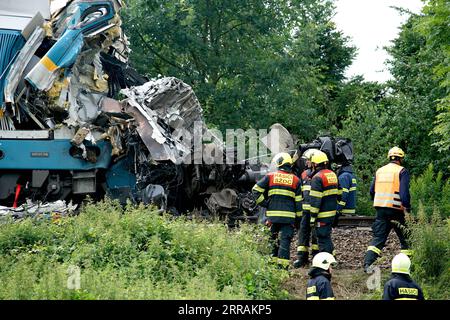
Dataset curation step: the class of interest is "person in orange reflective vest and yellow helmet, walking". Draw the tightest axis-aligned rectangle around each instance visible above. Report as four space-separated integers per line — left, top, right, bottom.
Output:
364 147 412 273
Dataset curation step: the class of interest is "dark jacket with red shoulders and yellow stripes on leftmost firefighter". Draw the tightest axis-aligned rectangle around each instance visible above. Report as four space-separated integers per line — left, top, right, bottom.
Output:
253 170 302 223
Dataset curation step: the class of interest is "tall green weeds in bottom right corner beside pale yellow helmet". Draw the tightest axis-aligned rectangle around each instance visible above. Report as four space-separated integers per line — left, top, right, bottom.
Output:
411 206 450 300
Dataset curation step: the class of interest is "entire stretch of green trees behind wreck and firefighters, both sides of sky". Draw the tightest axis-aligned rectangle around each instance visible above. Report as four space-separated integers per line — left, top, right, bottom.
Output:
123 0 450 216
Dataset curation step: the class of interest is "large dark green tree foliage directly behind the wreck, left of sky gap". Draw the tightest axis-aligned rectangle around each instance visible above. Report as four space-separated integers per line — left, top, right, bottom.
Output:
124 0 355 140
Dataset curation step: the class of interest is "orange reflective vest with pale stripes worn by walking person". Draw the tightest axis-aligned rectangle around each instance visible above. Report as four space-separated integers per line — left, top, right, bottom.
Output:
373 162 403 210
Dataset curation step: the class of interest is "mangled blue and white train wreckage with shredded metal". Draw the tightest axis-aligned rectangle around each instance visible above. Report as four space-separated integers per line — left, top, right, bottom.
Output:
0 0 356 224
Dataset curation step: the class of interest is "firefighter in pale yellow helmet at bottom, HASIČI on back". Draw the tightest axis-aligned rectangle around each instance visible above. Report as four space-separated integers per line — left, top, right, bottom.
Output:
383 253 425 300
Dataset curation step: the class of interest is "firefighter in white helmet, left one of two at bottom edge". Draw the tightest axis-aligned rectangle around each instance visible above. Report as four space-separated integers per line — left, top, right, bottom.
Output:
306 252 336 300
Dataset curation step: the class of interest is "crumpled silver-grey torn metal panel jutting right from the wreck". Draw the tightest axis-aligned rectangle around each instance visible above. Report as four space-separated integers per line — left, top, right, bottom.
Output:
121 77 203 163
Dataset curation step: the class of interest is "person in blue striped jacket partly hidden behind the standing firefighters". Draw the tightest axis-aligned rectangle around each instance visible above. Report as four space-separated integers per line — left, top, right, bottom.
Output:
334 162 356 226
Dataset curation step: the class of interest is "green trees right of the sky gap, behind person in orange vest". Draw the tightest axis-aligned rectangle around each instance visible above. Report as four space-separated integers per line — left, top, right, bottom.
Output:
335 0 450 214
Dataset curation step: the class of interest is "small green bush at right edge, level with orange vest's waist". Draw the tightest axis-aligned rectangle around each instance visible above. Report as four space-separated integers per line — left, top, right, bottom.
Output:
410 164 450 217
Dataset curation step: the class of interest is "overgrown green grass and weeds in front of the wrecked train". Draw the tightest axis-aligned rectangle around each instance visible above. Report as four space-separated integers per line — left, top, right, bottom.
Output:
0 200 287 299
